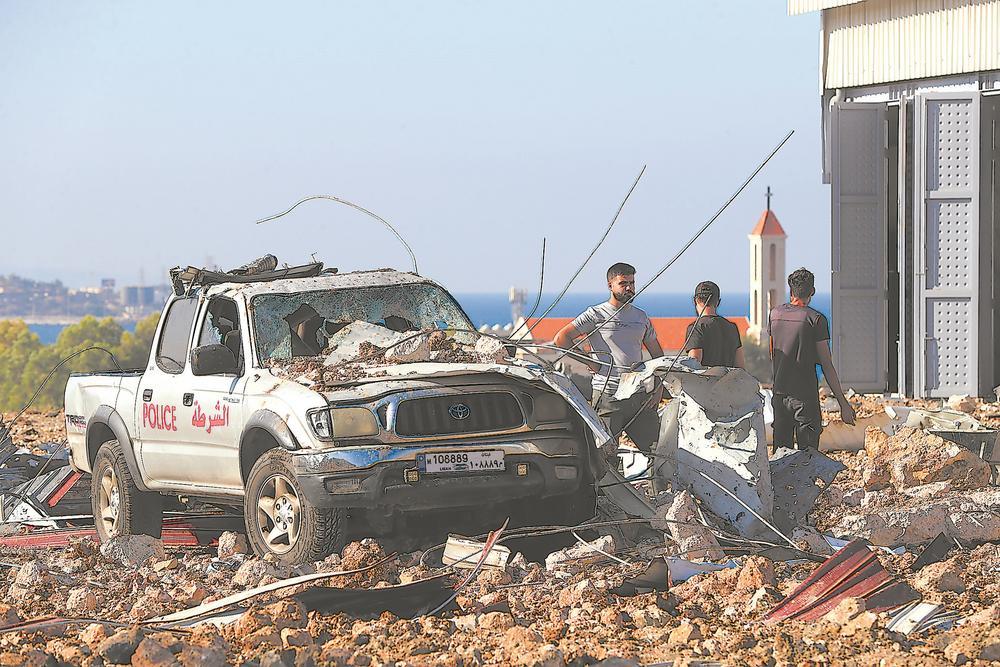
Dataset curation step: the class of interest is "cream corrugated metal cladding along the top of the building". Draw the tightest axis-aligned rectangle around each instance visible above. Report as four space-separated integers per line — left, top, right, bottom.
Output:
823 0 1000 89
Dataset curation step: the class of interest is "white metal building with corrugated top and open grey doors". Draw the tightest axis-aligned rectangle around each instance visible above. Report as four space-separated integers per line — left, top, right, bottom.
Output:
788 0 1000 397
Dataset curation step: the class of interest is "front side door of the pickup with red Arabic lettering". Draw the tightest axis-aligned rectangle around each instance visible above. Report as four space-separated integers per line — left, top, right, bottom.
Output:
184 296 249 490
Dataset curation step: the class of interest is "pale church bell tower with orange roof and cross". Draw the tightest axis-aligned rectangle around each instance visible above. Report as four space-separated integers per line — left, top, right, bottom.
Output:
748 187 788 341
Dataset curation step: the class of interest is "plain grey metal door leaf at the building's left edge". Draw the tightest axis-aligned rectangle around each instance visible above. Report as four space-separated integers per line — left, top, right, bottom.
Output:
830 102 888 392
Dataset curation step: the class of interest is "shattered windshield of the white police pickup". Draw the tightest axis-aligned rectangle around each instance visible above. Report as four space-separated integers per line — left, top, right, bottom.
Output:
251 284 475 364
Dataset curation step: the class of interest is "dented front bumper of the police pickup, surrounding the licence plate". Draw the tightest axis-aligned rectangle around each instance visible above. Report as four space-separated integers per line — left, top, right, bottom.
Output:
292 441 593 512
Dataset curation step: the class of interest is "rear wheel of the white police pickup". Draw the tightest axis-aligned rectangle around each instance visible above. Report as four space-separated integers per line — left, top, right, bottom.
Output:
90 440 163 543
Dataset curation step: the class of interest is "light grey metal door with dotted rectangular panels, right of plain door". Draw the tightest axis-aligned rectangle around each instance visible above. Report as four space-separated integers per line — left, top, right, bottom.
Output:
914 92 979 397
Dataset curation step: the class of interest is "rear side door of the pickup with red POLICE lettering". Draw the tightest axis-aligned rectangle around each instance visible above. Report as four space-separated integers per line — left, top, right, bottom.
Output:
135 296 198 488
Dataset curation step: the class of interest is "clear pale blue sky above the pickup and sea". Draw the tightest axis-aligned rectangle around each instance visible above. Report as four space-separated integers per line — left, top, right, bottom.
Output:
0 0 830 293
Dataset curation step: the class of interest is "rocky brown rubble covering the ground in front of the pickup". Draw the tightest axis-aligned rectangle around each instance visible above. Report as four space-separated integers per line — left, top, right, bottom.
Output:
0 396 1000 667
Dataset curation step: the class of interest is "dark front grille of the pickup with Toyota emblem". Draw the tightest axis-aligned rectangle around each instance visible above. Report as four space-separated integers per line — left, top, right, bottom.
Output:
396 392 524 436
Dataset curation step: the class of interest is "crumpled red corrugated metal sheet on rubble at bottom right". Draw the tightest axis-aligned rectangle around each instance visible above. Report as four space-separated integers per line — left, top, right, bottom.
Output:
764 540 919 624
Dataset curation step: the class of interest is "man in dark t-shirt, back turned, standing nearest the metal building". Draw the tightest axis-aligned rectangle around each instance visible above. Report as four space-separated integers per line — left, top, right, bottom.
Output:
768 269 854 449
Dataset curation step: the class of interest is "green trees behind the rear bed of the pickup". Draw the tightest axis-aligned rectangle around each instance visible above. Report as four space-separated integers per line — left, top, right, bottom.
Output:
0 313 160 412
